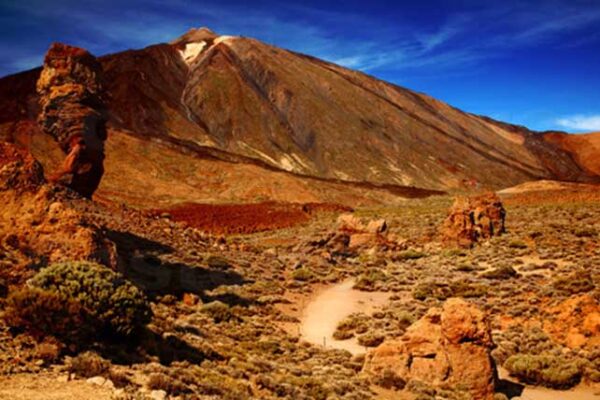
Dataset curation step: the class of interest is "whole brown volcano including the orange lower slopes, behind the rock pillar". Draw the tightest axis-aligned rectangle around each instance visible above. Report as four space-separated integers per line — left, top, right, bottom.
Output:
0 28 600 205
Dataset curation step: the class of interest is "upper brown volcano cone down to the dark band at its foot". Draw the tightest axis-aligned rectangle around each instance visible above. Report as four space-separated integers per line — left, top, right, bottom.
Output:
0 29 600 206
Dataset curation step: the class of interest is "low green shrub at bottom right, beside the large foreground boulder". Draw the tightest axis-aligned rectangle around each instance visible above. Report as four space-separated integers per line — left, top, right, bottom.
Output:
504 354 581 389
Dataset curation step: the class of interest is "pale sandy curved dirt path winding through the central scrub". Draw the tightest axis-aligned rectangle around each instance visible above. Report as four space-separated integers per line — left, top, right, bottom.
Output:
300 279 391 354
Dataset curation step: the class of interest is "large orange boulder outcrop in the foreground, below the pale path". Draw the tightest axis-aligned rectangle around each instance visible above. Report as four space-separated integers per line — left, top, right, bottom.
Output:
363 298 496 400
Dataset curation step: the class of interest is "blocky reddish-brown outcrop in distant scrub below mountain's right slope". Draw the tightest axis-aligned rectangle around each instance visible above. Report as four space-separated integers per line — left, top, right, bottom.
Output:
440 193 506 247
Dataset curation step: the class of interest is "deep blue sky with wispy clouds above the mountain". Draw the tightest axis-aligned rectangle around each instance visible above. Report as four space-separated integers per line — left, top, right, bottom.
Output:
0 0 600 132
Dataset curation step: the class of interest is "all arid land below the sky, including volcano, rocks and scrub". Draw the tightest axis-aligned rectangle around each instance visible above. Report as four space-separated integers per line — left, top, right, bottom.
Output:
0 29 600 400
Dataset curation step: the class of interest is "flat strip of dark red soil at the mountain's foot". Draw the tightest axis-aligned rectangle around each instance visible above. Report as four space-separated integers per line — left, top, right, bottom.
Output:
154 202 352 234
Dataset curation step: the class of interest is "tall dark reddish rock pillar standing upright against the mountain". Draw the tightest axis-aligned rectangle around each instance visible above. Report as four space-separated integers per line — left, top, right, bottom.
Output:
37 43 107 198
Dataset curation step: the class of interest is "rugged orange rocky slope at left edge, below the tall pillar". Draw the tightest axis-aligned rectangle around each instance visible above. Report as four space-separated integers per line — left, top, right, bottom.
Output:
0 143 116 284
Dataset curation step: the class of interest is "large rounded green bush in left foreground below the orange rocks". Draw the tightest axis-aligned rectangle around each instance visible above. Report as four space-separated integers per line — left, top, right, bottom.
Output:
30 262 151 336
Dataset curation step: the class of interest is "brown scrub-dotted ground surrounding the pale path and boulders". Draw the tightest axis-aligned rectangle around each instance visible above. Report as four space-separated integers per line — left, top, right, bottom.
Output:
0 173 600 399
